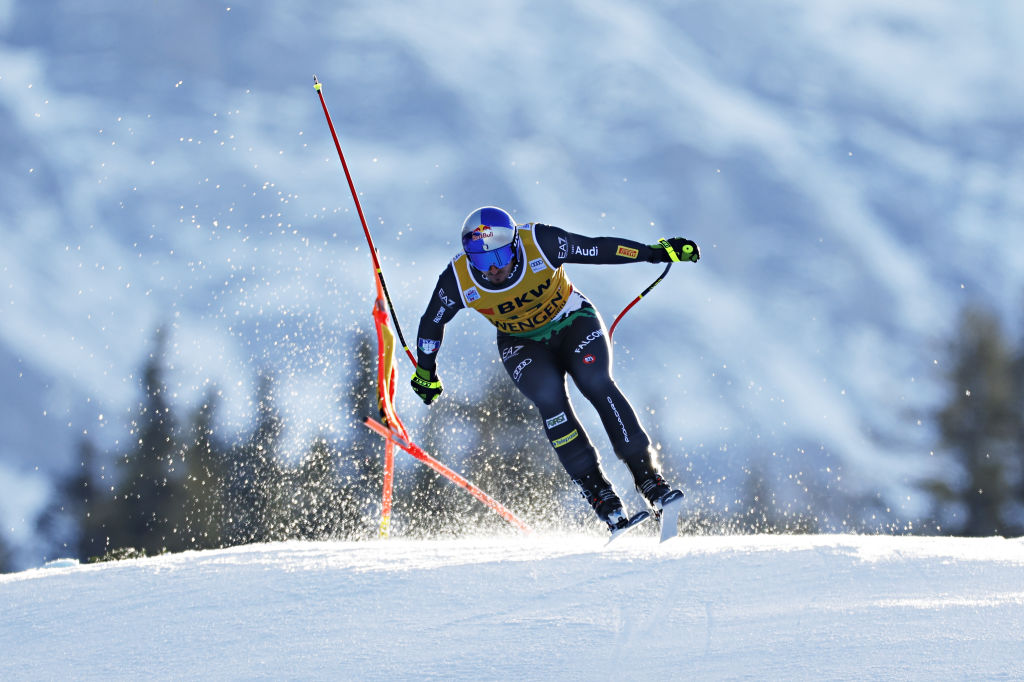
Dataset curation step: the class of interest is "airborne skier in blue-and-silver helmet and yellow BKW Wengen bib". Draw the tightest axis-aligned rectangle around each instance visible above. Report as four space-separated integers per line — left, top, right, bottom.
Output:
412 206 700 536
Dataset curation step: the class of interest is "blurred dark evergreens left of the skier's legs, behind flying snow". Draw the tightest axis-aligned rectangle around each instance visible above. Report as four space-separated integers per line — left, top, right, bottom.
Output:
34 333 567 561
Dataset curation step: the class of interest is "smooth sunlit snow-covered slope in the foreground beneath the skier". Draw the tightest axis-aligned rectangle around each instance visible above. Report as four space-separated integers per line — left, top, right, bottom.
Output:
0 536 1024 681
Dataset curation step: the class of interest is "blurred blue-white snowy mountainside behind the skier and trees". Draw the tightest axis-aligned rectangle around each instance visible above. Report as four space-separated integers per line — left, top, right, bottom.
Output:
0 0 1024 560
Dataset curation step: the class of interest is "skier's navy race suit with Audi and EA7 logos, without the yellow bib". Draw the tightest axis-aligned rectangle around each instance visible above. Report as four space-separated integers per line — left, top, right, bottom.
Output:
417 223 671 497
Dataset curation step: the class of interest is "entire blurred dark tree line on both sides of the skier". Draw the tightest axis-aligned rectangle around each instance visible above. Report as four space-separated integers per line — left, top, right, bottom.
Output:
0 307 1024 570
